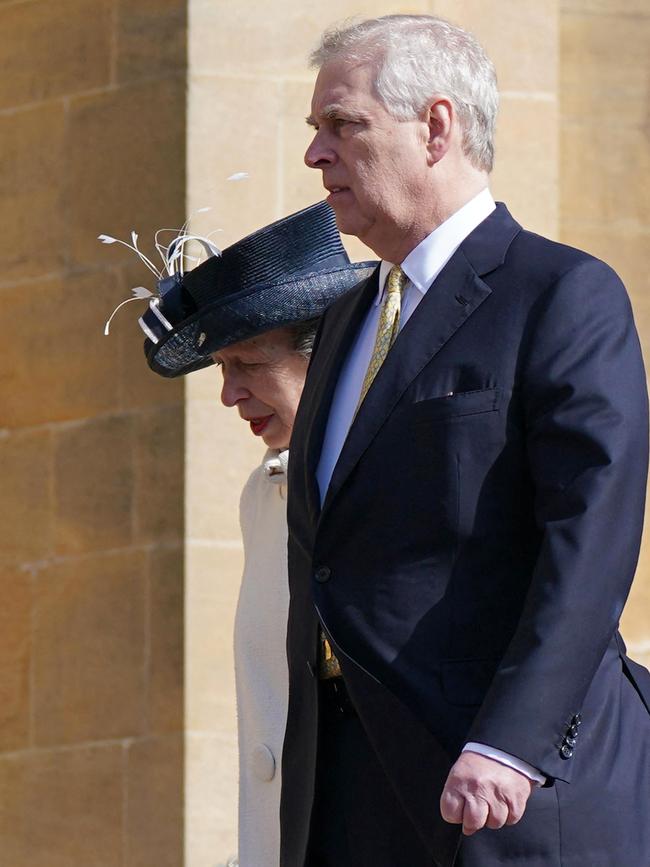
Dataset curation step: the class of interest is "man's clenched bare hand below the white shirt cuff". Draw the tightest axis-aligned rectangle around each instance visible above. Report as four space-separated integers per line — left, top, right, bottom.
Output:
440 752 534 836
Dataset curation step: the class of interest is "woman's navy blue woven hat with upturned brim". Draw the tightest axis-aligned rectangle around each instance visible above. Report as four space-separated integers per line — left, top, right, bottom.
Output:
140 202 377 377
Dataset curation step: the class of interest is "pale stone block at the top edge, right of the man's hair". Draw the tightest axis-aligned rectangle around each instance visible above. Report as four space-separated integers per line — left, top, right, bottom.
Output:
429 0 559 94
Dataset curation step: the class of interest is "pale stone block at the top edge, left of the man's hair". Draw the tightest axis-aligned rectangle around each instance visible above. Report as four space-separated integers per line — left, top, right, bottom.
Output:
189 0 427 79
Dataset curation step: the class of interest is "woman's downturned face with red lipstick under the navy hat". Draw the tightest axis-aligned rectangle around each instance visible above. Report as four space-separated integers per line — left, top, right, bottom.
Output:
212 328 308 449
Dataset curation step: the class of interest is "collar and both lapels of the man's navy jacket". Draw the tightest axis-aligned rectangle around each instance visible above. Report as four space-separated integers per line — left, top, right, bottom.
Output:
305 203 521 517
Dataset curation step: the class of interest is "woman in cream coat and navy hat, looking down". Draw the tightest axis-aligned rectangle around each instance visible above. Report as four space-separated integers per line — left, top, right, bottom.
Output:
127 202 374 867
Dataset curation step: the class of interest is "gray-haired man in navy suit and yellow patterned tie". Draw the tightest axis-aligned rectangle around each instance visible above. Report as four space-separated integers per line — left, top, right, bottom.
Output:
281 16 650 867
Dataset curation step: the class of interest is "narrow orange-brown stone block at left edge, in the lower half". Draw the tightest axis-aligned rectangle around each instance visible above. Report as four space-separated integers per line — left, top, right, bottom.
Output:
0 568 31 753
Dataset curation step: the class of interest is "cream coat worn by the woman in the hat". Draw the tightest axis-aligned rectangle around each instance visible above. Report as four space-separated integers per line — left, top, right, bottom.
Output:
235 450 289 867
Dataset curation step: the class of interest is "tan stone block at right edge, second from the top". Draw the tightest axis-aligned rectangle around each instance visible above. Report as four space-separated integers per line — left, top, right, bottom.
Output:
560 122 650 231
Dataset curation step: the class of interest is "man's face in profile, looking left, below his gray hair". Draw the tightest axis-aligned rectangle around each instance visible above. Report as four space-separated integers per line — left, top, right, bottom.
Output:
305 60 428 258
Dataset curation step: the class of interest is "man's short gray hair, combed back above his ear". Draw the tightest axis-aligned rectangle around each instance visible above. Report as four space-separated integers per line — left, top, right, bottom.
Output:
310 15 499 172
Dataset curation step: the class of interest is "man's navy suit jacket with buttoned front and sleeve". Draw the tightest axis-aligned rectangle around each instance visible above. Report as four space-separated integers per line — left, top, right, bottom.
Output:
282 205 650 867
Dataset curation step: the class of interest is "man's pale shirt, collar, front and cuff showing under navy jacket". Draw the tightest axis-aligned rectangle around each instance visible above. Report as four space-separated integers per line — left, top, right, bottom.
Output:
316 188 546 784
